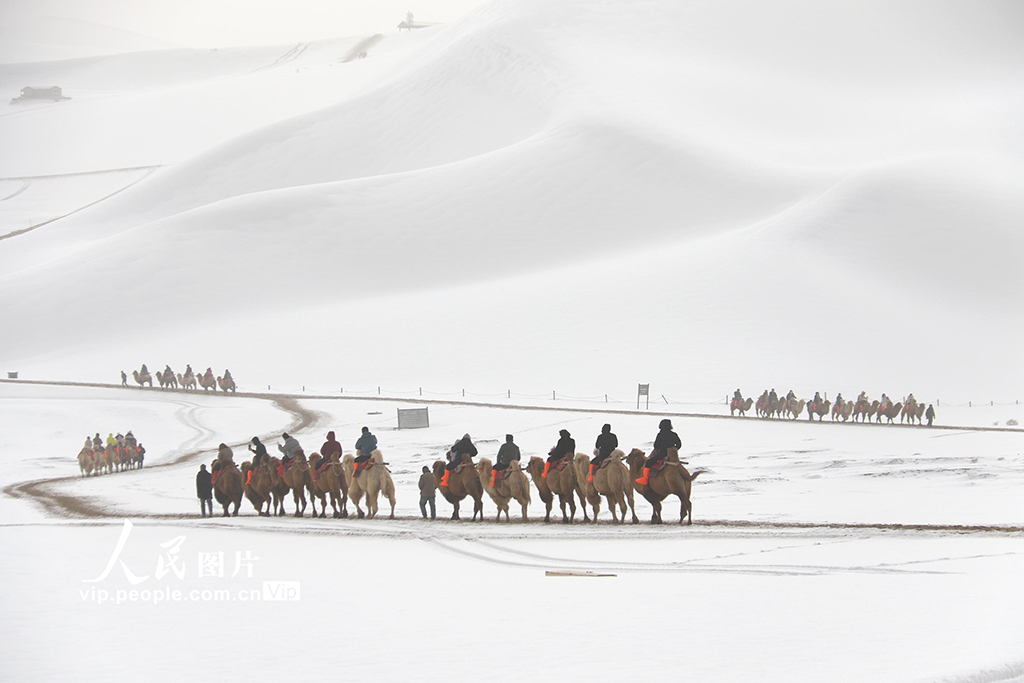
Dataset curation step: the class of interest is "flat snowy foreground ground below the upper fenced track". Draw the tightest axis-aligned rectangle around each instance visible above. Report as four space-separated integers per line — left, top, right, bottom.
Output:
0 383 1024 681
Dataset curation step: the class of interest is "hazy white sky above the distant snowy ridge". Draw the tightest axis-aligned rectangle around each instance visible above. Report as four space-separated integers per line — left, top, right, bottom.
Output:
0 0 486 47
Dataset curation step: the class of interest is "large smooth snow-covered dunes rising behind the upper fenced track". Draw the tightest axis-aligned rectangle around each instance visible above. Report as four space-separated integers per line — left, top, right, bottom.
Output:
0 0 1024 399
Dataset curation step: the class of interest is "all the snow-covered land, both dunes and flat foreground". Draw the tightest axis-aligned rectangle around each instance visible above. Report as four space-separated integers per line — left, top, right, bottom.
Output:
0 0 1024 682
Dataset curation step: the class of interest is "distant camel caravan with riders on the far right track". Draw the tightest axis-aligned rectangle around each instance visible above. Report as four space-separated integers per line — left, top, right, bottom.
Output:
729 389 935 427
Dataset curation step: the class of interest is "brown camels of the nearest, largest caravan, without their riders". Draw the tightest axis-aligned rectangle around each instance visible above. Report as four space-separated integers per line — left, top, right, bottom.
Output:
201 446 700 524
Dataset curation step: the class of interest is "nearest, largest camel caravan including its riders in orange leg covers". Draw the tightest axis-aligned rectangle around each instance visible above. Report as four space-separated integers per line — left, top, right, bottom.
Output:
200 420 699 524
